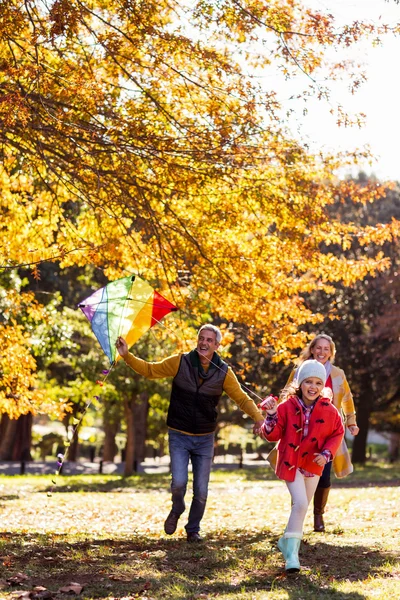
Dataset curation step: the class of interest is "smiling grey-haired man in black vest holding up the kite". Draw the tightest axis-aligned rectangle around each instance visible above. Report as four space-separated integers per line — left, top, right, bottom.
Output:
116 325 264 542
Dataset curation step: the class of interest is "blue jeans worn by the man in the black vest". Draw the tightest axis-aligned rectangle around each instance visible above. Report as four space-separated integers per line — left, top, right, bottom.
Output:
168 429 214 533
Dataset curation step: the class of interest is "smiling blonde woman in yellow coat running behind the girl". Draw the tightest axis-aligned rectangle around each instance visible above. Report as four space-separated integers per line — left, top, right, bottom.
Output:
286 333 359 531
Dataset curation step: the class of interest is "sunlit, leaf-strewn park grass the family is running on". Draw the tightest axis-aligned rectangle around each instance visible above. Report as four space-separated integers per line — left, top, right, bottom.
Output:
0 464 400 600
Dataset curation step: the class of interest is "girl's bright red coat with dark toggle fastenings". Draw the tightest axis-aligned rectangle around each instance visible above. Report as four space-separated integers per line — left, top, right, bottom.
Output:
264 396 344 481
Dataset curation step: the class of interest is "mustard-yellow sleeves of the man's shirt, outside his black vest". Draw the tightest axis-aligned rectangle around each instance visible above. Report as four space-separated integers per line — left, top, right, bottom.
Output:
124 352 264 421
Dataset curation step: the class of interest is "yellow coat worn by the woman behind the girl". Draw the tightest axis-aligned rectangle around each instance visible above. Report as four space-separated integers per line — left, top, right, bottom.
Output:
268 365 357 478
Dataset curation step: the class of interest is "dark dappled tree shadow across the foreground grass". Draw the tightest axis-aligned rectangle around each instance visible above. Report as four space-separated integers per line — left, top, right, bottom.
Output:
0 530 396 600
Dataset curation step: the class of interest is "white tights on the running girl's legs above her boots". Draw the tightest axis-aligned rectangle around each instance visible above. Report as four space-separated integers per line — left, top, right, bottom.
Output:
285 469 319 537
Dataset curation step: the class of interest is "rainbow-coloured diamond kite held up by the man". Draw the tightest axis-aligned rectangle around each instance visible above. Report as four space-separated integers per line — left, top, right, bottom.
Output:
78 275 178 364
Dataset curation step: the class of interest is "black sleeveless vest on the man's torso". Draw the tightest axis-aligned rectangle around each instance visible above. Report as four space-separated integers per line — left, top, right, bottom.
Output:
167 350 228 434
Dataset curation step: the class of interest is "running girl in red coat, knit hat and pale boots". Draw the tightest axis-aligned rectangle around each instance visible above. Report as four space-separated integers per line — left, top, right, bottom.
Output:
260 360 344 573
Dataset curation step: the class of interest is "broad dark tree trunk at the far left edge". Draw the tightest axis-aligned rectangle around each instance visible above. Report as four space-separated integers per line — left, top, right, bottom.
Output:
0 413 32 460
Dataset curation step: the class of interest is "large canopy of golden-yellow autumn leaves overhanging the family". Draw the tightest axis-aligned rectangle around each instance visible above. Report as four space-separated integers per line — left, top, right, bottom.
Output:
0 0 399 414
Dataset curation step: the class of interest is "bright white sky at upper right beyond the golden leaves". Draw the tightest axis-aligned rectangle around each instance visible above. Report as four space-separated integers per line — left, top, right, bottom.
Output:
262 0 400 181
